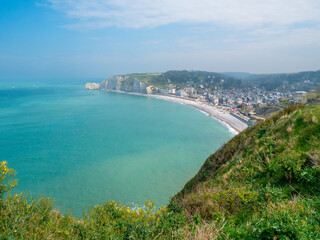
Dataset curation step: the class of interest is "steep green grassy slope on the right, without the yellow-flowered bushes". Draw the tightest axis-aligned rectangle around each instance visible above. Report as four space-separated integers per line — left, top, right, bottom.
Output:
170 90 320 239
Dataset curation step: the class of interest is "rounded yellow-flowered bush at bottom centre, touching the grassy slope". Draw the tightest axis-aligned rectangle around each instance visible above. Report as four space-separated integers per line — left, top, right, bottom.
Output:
80 201 170 239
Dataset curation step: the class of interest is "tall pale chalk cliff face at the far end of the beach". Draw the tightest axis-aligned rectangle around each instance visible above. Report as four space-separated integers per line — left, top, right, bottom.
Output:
100 76 147 93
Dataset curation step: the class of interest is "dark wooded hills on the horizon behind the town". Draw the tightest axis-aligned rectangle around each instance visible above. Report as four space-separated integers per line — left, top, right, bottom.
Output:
129 70 320 91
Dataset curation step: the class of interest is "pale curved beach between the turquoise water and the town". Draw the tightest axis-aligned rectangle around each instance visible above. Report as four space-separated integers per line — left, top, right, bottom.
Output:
99 90 248 135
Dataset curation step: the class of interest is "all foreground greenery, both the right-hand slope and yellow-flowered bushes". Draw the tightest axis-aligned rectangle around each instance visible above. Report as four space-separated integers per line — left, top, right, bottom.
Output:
0 89 320 240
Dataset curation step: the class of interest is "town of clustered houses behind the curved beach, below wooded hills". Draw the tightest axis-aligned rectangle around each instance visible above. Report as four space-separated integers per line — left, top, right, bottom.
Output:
147 84 306 125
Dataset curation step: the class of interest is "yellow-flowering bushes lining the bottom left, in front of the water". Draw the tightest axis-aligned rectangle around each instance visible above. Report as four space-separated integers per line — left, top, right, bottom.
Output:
0 165 186 239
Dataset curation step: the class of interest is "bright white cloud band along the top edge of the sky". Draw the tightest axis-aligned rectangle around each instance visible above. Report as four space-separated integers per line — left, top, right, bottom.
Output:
47 0 320 29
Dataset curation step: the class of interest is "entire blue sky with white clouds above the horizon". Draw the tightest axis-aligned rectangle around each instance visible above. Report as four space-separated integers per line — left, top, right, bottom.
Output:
0 0 320 79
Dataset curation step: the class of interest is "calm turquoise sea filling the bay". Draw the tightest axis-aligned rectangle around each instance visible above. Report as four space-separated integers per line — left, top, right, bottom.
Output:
0 82 232 214
